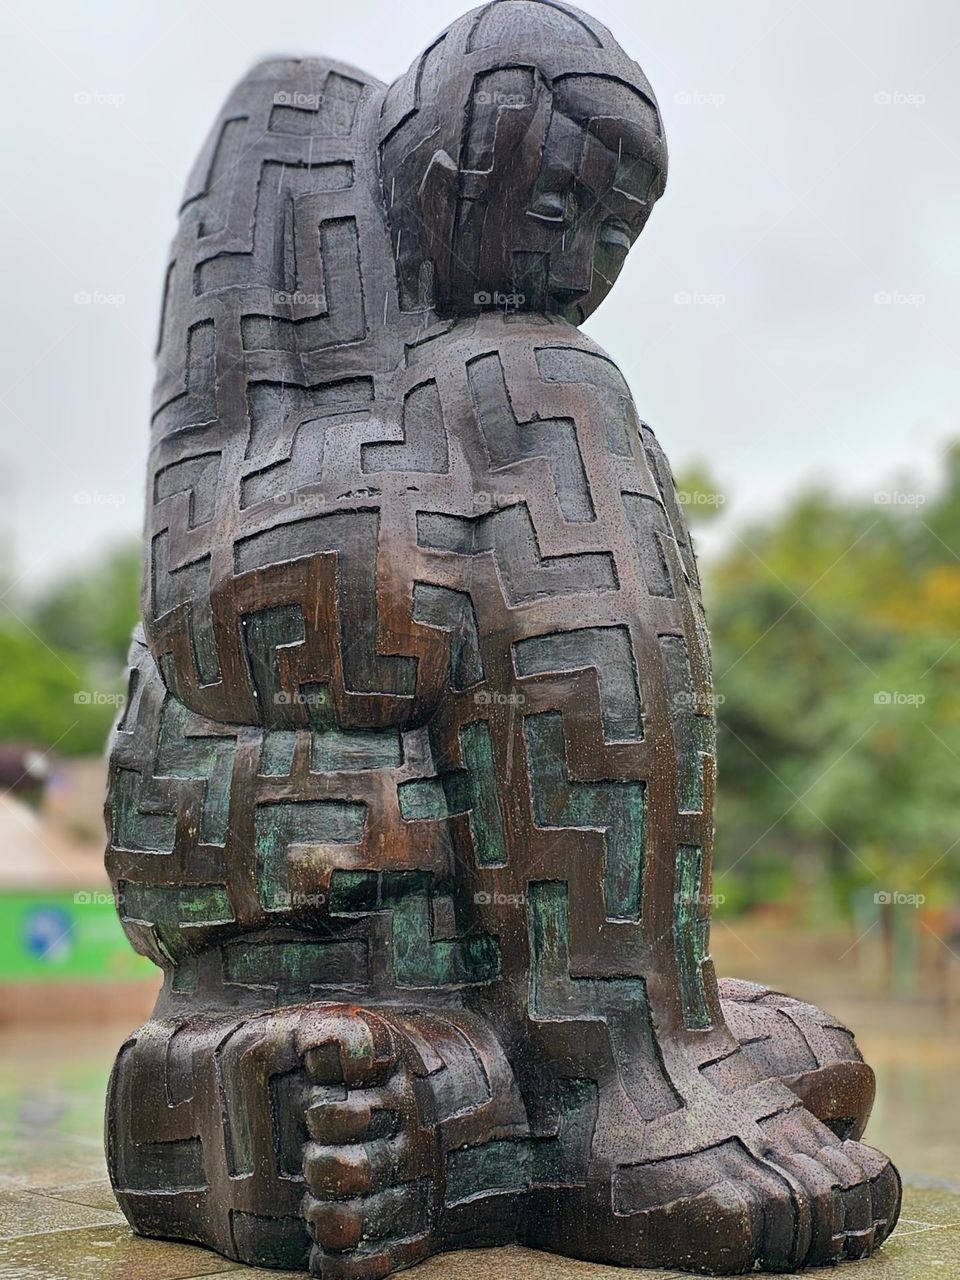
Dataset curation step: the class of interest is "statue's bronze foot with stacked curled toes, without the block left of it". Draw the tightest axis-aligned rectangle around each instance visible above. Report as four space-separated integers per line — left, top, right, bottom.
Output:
297 1006 529 1280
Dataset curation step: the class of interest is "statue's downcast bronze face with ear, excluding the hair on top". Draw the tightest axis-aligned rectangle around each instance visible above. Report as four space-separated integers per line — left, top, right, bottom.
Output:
421 76 663 324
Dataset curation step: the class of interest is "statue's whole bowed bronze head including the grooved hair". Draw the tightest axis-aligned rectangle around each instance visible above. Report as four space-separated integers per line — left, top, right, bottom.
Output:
380 0 667 324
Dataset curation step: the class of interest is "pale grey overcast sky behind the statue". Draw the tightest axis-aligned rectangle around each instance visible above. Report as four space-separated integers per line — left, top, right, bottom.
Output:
0 0 960 590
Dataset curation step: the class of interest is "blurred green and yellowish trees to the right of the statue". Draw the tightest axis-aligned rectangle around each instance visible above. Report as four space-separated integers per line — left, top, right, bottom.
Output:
705 465 960 915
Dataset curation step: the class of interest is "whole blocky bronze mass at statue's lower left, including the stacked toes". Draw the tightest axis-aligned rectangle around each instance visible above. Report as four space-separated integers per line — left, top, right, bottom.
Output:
108 1004 527 1280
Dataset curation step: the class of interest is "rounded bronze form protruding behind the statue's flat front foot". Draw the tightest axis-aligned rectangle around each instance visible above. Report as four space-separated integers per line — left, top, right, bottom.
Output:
719 978 876 1138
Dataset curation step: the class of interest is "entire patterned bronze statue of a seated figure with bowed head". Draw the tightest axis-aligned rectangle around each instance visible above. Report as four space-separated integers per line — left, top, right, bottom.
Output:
106 0 900 1277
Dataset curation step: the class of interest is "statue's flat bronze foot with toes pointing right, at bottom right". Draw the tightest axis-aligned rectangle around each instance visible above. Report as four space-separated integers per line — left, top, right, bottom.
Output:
524 1080 900 1274
